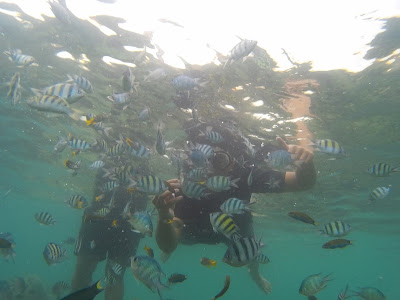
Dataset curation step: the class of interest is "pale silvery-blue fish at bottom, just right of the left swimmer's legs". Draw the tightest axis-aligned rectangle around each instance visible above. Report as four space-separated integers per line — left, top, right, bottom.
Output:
131 255 168 299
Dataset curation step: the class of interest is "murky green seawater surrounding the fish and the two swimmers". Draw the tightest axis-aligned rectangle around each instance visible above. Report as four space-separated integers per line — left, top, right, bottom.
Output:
0 4 400 300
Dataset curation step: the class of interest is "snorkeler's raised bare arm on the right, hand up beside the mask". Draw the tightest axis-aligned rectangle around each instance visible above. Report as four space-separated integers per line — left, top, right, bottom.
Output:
276 137 317 191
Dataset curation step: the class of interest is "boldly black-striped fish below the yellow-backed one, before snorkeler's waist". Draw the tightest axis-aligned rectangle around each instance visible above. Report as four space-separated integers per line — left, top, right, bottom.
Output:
222 237 263 267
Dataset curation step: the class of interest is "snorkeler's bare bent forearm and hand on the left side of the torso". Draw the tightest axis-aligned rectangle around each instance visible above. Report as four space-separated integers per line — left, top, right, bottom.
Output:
153 179 183 254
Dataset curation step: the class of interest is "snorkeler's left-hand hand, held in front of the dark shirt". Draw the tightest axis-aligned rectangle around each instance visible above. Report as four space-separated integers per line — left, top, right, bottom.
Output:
152 179 183 219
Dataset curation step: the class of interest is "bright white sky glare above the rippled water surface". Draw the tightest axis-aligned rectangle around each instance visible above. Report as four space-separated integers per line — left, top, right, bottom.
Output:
7 0 400 72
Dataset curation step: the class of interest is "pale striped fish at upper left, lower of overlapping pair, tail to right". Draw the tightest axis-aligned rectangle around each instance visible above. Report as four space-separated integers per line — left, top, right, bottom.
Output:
27 95 86 121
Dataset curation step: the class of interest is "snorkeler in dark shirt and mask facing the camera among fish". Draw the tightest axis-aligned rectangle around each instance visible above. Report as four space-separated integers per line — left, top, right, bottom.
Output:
153 123 316 294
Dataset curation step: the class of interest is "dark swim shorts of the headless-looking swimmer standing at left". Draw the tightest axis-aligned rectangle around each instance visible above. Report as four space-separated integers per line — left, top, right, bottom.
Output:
74 220 142 267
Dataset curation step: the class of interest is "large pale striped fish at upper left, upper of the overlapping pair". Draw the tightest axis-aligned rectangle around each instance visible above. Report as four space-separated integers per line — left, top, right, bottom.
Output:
31 83 85 104
